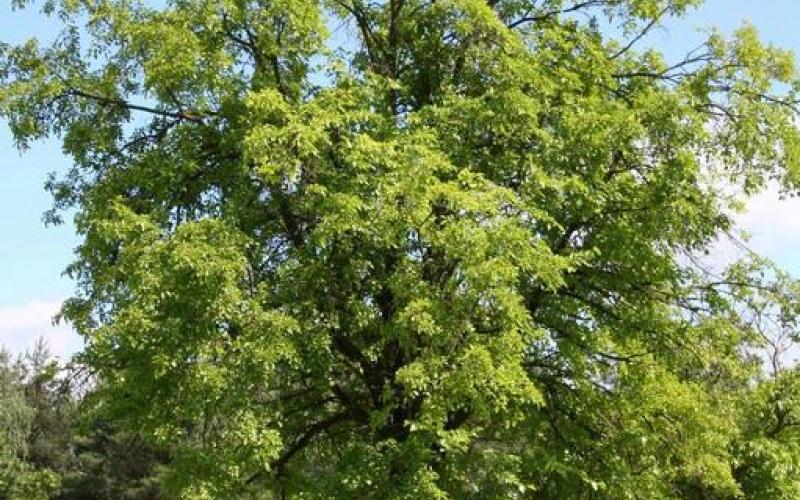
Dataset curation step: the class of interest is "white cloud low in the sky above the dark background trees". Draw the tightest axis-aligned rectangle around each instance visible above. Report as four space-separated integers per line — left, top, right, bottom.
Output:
0 300 83 359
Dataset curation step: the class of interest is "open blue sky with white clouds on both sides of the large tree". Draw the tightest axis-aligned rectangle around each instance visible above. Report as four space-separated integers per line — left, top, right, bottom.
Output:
0 0 800 355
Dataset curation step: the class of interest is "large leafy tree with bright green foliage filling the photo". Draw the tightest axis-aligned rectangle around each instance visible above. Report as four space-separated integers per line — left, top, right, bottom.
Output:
0 0 800 498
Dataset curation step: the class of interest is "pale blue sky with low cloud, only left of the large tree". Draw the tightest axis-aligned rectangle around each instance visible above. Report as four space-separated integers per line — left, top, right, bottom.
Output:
0 0 80 354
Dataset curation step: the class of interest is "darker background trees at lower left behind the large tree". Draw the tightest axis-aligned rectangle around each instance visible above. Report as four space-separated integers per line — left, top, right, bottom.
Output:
0 340 168 500
